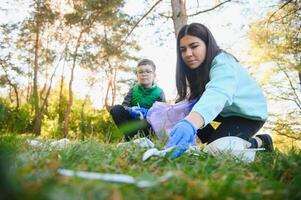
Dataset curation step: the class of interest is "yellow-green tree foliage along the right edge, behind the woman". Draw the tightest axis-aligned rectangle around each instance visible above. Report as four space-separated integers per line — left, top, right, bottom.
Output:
249 0 301 139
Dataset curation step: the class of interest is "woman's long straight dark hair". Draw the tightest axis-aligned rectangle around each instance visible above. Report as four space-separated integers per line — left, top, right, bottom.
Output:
176 23 222 102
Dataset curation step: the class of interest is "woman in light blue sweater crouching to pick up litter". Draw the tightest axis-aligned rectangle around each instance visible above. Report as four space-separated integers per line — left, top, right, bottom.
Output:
166 23 273 158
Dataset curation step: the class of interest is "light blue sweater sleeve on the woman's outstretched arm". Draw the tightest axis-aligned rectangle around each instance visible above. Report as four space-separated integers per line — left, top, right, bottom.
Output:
192 57 238 128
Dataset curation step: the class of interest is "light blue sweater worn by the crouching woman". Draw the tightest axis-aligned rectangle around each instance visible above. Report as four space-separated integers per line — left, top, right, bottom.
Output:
192 52 268 126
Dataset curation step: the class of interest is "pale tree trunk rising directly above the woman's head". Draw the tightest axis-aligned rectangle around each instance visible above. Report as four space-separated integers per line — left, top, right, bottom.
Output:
171 0 188 38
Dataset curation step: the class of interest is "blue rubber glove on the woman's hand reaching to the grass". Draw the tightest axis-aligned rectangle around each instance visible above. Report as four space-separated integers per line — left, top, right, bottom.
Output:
166 119 197 159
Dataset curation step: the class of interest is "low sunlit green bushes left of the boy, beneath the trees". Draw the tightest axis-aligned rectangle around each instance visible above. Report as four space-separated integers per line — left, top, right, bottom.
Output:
0 89 122 142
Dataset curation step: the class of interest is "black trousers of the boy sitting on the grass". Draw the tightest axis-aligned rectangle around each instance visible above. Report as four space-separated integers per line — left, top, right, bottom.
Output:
110 105 151 141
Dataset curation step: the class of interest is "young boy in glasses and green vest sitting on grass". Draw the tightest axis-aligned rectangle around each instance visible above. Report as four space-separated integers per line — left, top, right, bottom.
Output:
110 59 165 141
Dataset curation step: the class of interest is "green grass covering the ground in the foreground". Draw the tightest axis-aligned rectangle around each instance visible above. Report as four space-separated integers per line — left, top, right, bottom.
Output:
0 136 301 200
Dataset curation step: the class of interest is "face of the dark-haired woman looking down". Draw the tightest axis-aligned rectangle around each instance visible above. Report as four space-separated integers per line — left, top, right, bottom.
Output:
180 35 206 69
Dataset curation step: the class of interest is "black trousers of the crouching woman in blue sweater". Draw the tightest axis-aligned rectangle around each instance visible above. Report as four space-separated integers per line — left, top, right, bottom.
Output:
197 115 265 144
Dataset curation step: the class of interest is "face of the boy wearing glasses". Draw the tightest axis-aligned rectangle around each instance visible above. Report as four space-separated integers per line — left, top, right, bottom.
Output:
137 65 155 88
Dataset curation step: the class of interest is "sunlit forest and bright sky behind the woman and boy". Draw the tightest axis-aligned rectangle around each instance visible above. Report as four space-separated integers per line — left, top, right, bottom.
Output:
0 0 301 148
